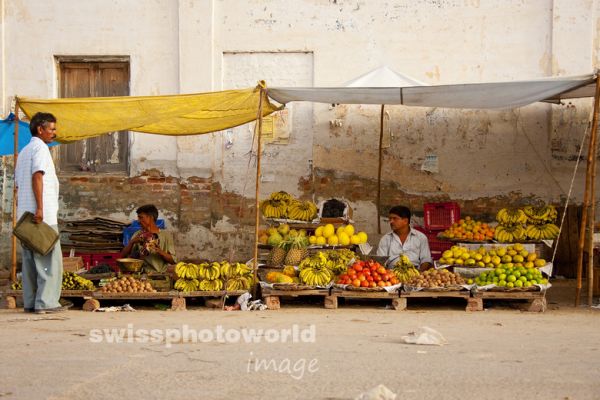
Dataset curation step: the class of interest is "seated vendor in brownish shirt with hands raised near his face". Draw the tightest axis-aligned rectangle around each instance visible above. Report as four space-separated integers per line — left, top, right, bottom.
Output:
121 204 175 272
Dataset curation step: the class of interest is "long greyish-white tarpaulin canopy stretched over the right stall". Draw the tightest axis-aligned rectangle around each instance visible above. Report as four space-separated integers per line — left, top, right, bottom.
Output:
267 74 596 109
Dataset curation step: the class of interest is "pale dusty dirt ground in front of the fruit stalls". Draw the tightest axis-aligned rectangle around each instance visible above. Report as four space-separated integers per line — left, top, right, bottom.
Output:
0 282 600 400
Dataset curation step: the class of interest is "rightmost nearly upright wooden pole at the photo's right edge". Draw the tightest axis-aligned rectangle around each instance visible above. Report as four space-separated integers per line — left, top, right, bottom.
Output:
587 78 600 307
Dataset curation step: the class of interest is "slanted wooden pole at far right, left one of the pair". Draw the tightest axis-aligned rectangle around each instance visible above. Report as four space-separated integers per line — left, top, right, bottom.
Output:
575 77 600 307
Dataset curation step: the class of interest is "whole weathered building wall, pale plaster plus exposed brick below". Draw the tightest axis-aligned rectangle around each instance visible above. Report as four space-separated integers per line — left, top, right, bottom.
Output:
0 0 600 266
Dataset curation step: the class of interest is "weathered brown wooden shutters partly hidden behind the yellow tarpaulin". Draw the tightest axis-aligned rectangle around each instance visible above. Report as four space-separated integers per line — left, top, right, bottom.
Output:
58 61 129 172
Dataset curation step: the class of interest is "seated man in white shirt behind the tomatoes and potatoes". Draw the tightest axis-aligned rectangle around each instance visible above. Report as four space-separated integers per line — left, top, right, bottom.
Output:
377 206 433 271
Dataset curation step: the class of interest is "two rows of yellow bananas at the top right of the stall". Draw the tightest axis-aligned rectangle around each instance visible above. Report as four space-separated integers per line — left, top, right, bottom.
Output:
494 204 559 243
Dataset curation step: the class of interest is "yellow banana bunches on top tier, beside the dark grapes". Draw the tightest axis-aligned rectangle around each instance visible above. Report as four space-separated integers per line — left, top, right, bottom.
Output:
260 191 318 221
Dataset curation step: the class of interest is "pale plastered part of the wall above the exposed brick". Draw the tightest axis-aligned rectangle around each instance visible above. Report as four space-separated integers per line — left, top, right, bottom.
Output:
2 0 600 203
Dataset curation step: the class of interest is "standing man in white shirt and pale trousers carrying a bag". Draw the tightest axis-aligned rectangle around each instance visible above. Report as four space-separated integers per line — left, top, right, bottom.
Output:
15 113 66 314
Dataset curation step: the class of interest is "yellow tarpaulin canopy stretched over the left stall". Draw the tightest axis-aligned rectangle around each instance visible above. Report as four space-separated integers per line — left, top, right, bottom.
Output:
18 85 278 143
